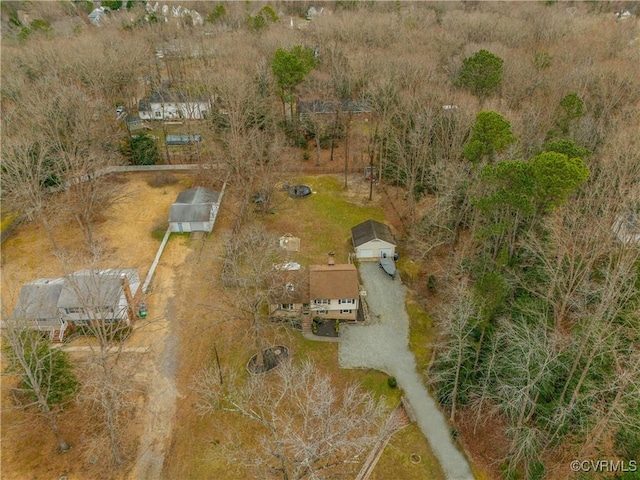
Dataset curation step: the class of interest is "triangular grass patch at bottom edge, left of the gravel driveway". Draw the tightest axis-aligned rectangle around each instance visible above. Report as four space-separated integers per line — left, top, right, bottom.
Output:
369 423 445 480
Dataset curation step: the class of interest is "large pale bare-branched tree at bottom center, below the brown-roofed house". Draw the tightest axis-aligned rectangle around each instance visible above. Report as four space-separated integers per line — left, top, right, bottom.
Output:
196 362 383 480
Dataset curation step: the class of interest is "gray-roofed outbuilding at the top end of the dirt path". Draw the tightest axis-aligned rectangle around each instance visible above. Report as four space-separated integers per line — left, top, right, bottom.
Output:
169 187 221 233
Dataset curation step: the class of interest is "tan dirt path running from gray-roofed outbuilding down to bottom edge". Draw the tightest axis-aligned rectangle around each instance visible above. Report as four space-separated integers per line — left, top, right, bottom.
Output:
129 237 189 480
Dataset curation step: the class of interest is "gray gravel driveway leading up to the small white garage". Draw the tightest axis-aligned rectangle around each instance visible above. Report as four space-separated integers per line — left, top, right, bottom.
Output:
339 263 474 480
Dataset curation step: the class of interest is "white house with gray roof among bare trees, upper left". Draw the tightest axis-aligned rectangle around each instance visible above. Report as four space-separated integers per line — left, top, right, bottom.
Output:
138 90 211 120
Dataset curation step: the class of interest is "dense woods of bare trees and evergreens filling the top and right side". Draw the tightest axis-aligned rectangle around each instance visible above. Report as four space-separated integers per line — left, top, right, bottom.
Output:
0 1 640 479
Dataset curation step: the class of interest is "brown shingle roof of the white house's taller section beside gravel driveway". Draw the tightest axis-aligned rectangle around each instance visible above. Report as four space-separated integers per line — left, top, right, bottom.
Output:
309 264 358 300
